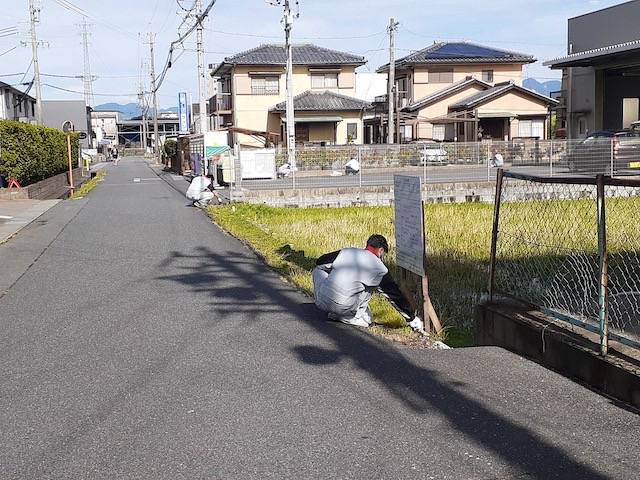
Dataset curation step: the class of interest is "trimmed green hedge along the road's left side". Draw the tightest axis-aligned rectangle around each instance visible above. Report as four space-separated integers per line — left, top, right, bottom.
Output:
0 120 80 186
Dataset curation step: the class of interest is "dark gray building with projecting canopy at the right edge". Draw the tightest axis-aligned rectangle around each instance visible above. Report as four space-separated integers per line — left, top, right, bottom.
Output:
545 0 640 138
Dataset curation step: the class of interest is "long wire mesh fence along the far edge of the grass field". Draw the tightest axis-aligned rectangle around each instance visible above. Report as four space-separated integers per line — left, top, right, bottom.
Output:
235 137 640 195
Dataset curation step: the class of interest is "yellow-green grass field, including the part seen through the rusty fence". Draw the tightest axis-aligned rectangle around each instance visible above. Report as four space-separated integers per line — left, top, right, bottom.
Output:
209 186 640 345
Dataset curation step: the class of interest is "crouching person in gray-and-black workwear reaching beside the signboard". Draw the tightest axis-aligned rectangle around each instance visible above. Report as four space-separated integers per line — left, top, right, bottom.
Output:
313 235 424 331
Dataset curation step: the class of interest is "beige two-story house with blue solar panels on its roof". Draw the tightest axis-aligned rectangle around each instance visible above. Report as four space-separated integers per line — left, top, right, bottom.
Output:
365 42 556 143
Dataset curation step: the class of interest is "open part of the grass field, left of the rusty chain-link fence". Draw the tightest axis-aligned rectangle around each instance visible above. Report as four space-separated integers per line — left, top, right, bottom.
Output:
209 204 493 344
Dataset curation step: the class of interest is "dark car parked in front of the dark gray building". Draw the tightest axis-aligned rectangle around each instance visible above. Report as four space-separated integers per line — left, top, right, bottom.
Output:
566 129 640 173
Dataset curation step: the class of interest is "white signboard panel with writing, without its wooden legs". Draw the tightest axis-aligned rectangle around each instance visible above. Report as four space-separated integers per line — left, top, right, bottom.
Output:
393 175 425 277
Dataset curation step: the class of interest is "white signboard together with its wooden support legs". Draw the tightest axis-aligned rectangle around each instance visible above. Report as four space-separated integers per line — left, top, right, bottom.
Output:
393 175 442 333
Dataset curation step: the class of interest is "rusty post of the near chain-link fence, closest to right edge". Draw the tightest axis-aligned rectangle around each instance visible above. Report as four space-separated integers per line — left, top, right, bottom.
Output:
596 175 609 356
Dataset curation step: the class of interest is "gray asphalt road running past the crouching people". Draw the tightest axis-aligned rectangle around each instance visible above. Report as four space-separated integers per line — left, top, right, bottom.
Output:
0 158 640 480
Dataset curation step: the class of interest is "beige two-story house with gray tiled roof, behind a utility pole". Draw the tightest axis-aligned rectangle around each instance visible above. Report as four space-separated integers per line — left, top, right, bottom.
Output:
211 44 369 147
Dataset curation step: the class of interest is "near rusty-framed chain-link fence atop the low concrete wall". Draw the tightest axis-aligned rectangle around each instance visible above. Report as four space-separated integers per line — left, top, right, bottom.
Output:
490 170 640 353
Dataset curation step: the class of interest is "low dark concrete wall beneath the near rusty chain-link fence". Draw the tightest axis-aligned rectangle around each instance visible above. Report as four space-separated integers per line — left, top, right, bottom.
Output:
475 303 640 408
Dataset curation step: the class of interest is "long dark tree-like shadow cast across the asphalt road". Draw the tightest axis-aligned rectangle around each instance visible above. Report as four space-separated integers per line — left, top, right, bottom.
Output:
155 247 608 479
